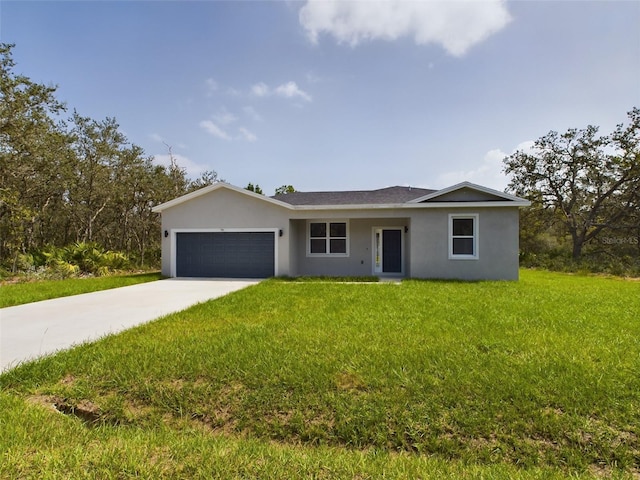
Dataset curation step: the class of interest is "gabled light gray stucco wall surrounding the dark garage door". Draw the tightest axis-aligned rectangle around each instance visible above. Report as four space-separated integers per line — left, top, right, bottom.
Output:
162 188 291 276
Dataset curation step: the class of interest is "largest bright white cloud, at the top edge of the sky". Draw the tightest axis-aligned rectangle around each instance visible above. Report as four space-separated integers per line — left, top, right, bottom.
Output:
299 0 511 56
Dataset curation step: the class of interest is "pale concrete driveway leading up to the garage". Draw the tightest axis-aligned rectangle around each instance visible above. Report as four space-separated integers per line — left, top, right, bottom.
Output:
0 278 260 372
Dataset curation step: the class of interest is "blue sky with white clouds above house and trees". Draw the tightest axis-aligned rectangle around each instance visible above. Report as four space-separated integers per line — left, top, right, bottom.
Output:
0 0 640 194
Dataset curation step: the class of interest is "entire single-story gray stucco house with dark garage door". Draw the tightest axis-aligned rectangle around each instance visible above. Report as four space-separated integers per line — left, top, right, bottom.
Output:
154 182 529 280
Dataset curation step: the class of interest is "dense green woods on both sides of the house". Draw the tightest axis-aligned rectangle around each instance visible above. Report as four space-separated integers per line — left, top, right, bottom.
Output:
0 43 640 275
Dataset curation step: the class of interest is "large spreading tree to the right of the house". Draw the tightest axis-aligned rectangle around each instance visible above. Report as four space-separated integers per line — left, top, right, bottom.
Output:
504 108 640 260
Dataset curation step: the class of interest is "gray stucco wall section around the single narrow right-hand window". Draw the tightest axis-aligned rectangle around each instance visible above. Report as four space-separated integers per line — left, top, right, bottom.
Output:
410 207 519 280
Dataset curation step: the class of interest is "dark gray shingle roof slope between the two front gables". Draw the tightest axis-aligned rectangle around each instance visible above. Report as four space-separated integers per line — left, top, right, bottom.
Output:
271 187 436 205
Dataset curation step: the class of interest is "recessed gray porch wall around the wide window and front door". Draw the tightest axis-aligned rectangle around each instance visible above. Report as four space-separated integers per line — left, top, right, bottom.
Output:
291 218 409 276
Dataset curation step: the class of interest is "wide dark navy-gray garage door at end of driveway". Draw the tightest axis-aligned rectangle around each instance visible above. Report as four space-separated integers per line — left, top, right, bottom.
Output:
175 231 275 278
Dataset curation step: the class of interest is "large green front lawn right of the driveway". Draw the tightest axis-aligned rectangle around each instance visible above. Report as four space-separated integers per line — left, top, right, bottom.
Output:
0 271 640 478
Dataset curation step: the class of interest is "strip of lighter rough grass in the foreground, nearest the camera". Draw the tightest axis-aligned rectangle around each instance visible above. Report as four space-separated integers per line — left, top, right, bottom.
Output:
0 392 576 480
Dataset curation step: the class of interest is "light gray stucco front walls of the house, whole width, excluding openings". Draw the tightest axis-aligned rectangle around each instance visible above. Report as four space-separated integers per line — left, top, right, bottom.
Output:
162 188 519 280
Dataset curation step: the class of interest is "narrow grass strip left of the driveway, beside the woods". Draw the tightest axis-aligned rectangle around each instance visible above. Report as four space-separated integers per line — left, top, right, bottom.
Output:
0 272 162 308
